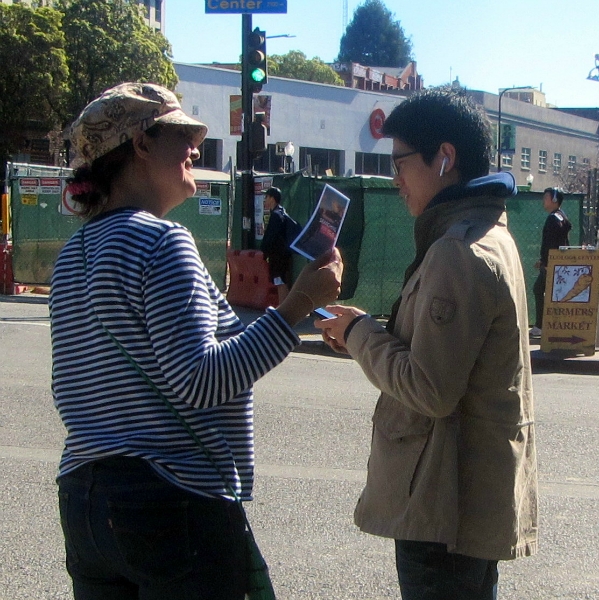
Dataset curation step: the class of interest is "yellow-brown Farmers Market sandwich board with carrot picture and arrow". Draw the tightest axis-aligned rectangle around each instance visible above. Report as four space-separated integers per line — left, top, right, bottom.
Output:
541 248 599 356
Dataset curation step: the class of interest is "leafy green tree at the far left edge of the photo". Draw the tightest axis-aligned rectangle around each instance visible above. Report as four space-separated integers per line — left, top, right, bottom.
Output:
0 4 68 165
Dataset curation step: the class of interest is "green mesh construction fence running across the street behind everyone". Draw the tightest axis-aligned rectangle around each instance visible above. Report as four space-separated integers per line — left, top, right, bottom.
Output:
7 164 588 326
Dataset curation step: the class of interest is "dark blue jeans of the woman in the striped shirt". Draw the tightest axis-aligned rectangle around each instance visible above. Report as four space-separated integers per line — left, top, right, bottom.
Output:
58 457 247 600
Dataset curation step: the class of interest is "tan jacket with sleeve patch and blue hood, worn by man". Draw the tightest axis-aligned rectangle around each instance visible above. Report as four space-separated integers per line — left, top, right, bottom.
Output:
346 197 537 560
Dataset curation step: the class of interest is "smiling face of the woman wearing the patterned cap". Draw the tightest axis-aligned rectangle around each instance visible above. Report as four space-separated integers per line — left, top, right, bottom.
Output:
146 125 199 208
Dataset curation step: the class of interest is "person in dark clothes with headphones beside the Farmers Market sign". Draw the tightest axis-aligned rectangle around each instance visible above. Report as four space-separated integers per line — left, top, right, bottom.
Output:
530 188 572 337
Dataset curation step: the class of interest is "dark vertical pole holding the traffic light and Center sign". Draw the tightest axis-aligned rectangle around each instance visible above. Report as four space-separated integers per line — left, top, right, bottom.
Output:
240 14 256 250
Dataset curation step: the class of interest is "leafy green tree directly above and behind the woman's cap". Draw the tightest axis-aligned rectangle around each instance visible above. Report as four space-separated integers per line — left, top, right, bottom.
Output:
58 0 178 125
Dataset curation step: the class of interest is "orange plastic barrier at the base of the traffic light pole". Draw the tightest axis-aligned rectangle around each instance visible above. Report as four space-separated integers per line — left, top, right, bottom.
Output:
227 250 279 310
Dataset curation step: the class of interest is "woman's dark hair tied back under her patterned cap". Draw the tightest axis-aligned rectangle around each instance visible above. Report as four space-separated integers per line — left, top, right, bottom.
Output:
67 124 164 219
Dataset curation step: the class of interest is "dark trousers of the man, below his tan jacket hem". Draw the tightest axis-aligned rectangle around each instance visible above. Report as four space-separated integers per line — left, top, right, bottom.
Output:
395 540 499 600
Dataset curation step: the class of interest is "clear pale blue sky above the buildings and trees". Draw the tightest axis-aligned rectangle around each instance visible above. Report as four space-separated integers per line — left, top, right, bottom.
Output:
164 0 599 108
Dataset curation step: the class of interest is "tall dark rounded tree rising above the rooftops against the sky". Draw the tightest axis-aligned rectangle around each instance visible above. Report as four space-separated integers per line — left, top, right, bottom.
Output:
337 0 412 68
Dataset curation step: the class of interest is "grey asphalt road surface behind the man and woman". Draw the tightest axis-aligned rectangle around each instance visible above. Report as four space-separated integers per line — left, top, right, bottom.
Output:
0 298 599 600
